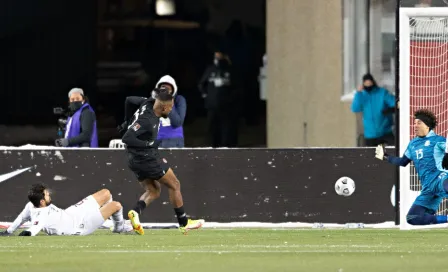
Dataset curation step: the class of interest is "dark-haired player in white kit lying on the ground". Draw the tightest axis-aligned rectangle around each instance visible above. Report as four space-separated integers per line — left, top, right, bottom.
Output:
1 184 132 236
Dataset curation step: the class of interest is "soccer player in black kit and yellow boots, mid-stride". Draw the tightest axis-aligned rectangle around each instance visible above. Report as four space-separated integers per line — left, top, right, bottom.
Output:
122 88 204 235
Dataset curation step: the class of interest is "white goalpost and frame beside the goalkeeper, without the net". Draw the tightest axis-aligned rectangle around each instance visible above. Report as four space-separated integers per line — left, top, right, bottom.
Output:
397 7 448 230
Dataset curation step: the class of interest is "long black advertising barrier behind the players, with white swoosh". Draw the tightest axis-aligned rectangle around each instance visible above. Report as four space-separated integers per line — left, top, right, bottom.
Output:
0 148 395 223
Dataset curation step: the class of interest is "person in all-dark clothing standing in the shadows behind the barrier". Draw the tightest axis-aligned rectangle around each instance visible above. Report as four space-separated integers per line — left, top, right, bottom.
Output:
198 50 238 147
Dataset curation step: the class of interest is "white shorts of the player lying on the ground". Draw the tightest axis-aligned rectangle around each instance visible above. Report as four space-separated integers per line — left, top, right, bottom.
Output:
65 195 105 235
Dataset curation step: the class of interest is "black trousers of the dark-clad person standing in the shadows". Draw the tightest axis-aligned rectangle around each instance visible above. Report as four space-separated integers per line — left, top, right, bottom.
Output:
208 109 238 147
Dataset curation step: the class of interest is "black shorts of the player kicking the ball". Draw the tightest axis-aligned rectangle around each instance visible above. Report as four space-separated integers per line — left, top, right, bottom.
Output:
128 153 170 181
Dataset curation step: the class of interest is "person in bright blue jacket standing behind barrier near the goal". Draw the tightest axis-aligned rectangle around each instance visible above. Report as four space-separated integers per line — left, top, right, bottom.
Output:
352 74 395 146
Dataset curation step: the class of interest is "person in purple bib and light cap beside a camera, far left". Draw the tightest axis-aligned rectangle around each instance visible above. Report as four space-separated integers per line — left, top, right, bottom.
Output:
56 88 98 147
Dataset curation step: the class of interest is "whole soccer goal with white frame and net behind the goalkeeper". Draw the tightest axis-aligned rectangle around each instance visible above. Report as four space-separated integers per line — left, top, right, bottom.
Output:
399 8 448 229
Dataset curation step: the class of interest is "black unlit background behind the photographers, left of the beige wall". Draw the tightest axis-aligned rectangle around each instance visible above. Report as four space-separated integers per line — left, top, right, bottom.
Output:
0 0 266 147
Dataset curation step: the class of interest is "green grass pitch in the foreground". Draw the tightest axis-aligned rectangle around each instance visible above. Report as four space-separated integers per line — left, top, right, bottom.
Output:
0 229 448 272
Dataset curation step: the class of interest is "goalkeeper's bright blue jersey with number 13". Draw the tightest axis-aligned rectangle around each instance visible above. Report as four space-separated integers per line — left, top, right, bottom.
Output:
404 131 446 191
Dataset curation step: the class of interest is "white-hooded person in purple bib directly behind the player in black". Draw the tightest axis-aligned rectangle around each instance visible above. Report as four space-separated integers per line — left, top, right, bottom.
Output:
156 75 187 148
